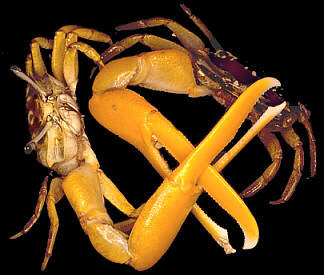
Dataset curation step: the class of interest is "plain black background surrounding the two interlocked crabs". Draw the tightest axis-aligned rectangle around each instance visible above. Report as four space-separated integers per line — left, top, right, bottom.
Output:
0 1 323 274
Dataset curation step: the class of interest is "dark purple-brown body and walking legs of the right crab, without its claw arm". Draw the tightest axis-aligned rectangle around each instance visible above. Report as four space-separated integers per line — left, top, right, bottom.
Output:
102 5 316 204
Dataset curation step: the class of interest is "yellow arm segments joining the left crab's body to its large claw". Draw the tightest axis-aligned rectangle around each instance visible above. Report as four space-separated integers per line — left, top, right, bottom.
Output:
62 163 131 263
